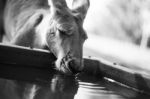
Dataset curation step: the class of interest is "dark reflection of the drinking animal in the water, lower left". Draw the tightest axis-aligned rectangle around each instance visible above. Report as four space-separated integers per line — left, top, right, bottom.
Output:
0 74 78 99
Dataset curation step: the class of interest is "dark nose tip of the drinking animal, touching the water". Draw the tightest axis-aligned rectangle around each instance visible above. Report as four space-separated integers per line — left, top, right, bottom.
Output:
68 60 82 74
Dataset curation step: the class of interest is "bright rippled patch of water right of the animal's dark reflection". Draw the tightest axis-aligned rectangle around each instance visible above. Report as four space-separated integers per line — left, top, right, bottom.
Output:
74 75 127 99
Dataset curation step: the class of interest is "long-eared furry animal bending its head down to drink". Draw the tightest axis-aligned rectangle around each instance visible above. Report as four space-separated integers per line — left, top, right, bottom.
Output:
1 0 89 74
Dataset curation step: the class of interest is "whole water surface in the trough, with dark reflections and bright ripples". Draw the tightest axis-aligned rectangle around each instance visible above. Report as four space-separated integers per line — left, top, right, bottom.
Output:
0 66 150 99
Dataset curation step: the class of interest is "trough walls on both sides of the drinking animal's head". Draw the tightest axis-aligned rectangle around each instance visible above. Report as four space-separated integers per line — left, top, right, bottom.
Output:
0 44 150 94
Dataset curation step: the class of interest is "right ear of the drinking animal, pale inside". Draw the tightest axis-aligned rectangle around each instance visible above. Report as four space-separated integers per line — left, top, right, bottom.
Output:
72 0 90 20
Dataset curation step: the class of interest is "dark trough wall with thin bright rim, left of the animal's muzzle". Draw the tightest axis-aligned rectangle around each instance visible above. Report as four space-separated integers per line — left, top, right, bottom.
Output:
0 44 56 67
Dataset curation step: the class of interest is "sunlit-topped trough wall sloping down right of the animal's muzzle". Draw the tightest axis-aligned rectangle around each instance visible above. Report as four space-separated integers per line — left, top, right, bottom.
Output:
84 59 150 94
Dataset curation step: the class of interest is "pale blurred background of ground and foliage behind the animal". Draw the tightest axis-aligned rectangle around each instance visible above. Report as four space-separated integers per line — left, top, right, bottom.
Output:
67 0 150 72
